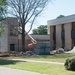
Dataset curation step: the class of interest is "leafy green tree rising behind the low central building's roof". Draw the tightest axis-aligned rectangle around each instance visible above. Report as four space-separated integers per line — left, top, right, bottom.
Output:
32 25 47 35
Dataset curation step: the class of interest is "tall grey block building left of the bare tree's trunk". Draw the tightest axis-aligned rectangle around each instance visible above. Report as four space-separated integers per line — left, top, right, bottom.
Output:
0 17 18 52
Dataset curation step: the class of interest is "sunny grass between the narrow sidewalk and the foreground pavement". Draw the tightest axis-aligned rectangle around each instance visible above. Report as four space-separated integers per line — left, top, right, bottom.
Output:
0 59 75 75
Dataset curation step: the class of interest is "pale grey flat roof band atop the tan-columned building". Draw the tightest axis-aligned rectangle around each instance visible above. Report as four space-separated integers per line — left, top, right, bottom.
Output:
47 14 75 26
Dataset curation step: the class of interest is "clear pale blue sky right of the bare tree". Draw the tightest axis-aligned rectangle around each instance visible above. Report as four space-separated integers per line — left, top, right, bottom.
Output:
26 0 75 33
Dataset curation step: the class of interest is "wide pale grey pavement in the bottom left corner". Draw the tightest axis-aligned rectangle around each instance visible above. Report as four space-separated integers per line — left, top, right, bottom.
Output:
0 67 45 75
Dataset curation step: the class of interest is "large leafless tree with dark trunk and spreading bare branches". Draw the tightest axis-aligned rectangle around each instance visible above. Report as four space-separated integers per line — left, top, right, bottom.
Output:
8 0 51 50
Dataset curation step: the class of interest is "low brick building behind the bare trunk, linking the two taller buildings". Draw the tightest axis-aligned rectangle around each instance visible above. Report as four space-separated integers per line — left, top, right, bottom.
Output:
18 34 50 51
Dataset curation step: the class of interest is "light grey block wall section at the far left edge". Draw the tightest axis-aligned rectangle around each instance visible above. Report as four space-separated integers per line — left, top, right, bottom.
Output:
0 24 8 52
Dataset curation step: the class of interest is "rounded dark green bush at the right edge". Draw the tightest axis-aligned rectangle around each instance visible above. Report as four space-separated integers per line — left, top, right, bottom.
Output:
64 56 75 71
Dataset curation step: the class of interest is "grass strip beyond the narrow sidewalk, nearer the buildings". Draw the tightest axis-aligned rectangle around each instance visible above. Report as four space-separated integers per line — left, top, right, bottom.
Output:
4 54 75 62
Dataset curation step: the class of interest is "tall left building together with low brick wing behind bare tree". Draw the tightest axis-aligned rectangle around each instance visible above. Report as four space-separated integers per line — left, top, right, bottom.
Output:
0 17 50 52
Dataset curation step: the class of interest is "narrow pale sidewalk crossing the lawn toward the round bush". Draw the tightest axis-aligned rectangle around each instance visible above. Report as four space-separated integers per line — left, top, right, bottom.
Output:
9 59 64 65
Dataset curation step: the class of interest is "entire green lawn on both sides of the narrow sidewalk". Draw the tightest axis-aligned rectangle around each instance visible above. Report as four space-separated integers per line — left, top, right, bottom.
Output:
0 54 75 75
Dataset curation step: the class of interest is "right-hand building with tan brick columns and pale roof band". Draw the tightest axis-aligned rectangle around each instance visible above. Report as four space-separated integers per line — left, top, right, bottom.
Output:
47 14 75 50
